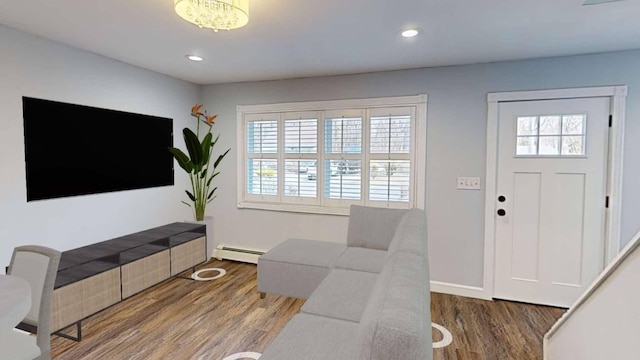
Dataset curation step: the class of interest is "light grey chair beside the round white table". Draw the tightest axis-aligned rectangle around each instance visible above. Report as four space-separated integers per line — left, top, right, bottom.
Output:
0 245 60 360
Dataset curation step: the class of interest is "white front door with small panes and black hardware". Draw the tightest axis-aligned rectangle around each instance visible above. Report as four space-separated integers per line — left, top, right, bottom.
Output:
494 97 610 307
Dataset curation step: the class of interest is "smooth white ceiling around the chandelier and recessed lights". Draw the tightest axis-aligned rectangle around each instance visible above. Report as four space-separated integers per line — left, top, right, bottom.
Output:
0 0 640 84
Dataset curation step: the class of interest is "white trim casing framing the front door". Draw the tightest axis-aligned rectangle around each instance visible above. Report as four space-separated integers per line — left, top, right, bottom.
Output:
482 86 627 300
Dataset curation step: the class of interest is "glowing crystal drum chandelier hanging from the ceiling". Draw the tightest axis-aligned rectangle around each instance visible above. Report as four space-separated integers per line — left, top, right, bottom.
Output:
173 0 249 32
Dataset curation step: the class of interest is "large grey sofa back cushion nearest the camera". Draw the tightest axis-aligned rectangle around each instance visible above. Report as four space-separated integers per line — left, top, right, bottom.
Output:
357 252 433 360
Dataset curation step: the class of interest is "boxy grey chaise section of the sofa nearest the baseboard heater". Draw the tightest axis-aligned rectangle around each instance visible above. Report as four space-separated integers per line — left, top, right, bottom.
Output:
258 239 346 299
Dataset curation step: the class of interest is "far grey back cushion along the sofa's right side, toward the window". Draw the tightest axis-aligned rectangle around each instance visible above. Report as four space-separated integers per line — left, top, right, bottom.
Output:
385 209 427 262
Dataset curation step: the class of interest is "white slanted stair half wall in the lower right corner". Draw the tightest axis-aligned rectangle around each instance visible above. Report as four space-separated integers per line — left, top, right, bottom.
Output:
544 229 640 360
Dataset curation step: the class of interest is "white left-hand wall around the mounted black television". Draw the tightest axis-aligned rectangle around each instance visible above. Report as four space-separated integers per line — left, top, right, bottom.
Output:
0 25 199 267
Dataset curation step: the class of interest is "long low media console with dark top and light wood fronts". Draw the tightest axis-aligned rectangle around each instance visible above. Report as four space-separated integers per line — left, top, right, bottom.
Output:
46 223 207 341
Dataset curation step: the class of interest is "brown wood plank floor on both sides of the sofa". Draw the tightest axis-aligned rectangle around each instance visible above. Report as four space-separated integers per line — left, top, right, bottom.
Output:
51 260 564 360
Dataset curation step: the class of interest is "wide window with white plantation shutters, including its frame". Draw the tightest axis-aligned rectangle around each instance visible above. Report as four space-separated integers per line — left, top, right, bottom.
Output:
238 95 426 214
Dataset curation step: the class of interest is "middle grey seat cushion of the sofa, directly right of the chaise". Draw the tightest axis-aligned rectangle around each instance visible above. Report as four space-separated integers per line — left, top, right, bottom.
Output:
301 269 378 322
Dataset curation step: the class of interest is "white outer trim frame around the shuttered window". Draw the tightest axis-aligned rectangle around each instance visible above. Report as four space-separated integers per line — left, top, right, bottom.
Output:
236 94 427 215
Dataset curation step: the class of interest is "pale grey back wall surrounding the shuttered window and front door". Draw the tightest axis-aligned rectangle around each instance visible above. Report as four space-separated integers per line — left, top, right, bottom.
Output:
202 51 640 287
